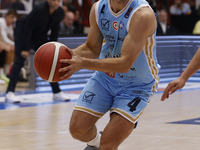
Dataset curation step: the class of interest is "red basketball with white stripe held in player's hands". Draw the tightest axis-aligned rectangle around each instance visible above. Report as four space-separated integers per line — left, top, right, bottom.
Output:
34 42 71 82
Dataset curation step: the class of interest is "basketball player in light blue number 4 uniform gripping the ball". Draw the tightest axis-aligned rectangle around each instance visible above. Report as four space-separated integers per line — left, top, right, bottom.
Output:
60 0 159 150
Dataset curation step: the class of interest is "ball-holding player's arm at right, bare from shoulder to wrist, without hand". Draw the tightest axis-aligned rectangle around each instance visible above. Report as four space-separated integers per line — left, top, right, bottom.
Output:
79 7 156 73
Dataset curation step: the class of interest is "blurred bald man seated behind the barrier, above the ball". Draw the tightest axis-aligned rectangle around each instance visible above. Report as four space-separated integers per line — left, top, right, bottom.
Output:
59 11 75 36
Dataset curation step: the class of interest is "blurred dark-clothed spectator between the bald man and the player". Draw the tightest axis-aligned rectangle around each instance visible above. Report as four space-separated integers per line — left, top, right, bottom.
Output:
73 9 84 35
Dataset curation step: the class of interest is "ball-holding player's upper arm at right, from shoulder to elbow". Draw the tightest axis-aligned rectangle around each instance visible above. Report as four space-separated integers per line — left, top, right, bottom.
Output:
121 7 157 71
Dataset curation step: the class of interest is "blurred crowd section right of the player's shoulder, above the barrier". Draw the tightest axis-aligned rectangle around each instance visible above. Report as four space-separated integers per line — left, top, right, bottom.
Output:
155 0 200 35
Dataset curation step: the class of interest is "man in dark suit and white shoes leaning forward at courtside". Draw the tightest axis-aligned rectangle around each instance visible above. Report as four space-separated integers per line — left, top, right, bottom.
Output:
5 0 69 103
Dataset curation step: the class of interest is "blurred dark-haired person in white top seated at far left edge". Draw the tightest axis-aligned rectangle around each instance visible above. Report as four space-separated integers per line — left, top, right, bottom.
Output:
0 9 17 83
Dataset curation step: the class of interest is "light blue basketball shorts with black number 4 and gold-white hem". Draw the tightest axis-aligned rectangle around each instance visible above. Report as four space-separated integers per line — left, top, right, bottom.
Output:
74 74 155 124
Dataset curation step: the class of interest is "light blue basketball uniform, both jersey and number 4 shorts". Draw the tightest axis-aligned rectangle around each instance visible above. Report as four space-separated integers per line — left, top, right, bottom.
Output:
74 0 159 124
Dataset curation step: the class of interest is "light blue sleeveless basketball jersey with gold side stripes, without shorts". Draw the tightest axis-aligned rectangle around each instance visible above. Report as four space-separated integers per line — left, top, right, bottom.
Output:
95 0 160 93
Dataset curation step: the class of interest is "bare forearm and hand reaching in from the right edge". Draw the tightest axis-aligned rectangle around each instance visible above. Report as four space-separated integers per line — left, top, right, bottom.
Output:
161 48 200 101
